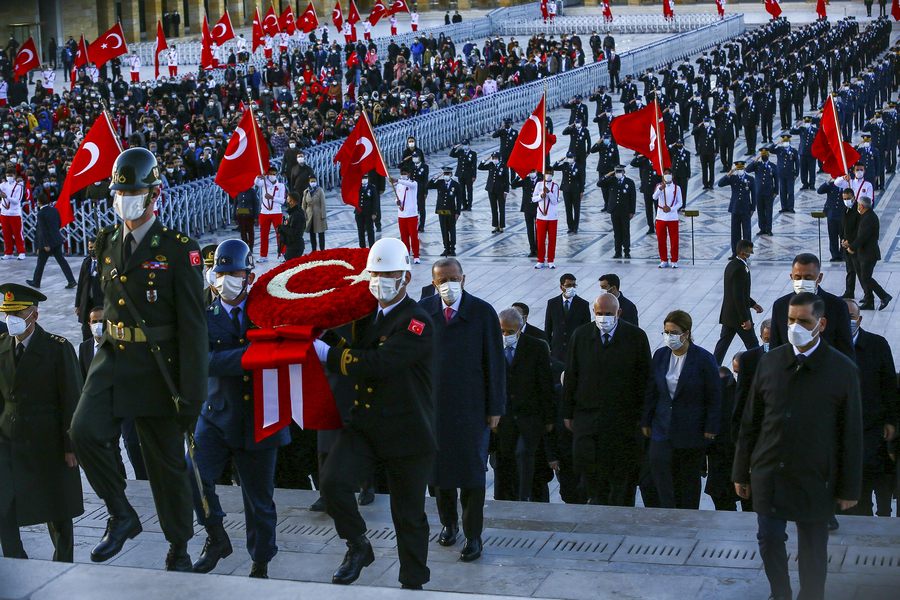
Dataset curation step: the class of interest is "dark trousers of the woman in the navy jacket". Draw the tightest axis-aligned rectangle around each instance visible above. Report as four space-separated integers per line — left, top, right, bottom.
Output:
650 440 704 510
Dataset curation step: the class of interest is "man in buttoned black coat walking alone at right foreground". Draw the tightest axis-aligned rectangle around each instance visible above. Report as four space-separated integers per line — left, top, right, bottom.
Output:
732 292 863 600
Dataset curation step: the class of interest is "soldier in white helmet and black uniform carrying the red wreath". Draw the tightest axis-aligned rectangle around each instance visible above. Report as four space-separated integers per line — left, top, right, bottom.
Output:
315 238 437 589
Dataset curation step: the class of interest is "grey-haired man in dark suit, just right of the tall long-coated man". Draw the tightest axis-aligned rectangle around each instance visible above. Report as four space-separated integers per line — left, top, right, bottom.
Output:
494 307 556 502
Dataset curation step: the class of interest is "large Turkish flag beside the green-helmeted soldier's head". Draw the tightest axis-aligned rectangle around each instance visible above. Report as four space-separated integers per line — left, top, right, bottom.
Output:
56 111 122 227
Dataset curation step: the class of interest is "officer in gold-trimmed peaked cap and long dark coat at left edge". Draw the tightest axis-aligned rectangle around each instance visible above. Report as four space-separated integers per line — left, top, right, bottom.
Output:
0 283 82 562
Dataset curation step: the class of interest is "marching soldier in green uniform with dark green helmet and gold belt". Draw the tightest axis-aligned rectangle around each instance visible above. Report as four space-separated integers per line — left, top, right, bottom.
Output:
71 148 209 571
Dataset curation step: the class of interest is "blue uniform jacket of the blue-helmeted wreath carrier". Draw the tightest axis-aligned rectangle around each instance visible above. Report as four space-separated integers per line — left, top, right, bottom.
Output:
196 298 291 450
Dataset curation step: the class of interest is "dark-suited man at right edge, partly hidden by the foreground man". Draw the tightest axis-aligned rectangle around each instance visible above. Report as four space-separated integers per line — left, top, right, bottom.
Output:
846 300 900 517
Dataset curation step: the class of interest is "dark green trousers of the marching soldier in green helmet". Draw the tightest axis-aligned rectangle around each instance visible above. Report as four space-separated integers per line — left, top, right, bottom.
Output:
69 382 194 544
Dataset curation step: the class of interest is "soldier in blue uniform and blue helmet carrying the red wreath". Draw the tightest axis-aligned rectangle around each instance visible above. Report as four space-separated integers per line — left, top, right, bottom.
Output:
187 240 291 579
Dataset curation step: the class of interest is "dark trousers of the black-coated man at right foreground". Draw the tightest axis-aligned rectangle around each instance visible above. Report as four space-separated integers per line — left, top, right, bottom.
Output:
756 513 828 600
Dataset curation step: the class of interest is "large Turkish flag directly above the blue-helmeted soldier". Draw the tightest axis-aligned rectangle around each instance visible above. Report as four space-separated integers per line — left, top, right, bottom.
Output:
215 110 269 198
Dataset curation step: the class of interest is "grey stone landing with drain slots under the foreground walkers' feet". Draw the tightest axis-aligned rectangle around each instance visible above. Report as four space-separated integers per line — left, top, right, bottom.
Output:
0 482 900 600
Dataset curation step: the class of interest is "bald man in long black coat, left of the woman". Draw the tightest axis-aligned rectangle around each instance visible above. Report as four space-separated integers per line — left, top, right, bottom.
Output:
563 293 650 506
